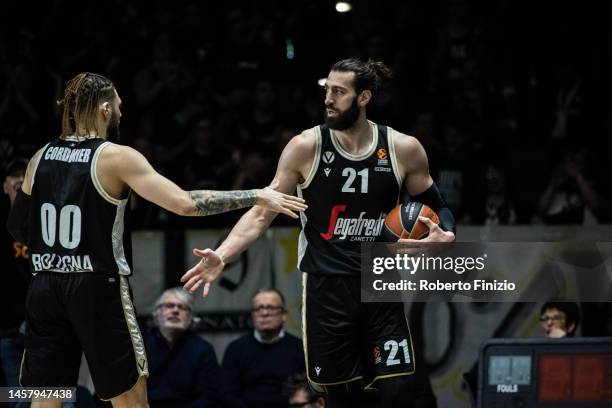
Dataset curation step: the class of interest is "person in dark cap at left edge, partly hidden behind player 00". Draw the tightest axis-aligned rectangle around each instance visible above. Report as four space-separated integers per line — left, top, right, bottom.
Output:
0 158 30 406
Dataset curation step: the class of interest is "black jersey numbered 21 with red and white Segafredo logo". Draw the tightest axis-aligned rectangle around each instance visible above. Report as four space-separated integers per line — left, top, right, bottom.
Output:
298 122 402 275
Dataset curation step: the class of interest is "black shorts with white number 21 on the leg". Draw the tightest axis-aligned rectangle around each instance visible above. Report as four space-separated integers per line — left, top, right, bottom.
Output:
302 273 415 388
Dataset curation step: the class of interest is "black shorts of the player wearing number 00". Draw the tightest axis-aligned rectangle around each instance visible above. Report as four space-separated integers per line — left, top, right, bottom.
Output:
20 272 149 400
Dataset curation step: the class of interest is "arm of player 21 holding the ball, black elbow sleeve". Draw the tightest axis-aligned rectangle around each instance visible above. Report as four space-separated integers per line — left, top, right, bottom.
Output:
393 133 455 242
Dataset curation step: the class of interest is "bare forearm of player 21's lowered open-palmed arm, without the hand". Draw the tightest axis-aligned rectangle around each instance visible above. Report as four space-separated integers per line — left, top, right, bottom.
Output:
215 207 276 263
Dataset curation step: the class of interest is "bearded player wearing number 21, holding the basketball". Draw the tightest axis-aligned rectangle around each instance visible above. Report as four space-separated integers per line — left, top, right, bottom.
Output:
182 58 455 408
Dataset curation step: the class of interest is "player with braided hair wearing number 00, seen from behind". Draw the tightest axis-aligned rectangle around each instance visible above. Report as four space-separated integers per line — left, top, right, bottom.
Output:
8 73 305 408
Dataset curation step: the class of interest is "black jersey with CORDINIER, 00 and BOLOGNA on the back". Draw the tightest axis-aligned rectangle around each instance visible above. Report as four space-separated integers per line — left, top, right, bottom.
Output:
29 138 132 275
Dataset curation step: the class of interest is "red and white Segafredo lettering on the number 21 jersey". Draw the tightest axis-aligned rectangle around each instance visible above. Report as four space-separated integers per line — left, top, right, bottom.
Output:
321 205 387 242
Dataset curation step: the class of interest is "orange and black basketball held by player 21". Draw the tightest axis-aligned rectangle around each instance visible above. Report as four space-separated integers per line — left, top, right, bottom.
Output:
381 202 440 242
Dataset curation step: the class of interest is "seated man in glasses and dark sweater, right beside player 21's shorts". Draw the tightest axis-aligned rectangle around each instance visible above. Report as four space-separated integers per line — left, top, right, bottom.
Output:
223 289 305 408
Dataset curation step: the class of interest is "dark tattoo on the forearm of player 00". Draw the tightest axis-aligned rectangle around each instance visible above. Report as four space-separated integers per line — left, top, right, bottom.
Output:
189 190 257 216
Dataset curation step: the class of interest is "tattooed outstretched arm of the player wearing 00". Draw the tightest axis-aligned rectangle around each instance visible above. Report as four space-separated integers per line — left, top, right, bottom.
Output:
97 144 306 218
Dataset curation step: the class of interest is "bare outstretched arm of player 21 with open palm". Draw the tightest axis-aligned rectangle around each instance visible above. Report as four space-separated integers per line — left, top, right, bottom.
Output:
181 129 316 296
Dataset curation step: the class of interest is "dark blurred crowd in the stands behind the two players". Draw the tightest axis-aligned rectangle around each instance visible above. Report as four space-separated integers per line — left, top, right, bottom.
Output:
0 0 612 228
